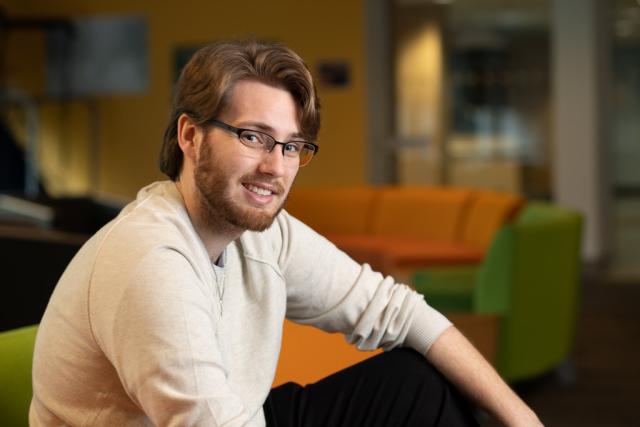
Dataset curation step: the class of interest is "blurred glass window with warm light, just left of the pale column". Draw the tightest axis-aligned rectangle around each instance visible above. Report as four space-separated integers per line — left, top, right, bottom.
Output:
393 0 551 197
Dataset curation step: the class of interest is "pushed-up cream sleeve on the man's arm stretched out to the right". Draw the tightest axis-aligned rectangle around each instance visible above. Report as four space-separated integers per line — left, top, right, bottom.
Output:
278 213 451 354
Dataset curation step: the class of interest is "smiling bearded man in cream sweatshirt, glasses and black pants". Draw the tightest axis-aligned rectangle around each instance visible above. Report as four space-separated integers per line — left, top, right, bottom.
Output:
30 42 539 426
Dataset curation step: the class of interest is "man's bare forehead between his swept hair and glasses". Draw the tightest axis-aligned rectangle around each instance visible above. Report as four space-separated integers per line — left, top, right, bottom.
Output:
221 80 300 135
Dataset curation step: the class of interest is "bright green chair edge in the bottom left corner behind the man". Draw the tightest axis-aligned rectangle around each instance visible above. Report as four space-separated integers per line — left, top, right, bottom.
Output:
0 326 37 427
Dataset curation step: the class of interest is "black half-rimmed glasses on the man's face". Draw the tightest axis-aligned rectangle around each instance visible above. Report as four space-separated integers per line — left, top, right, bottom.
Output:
208 119 319 167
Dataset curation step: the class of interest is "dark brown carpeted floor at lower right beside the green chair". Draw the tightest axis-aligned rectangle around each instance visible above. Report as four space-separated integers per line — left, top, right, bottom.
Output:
482 280 640 427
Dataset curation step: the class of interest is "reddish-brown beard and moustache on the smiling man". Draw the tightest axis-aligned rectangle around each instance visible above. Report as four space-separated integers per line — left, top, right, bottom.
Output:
194 141 286 231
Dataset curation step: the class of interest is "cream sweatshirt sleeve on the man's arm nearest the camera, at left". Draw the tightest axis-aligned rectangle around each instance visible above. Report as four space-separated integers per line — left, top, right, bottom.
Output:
91 248 260 426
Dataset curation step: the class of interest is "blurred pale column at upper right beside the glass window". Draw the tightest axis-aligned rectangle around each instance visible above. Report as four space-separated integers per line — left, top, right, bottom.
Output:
551 0 611 262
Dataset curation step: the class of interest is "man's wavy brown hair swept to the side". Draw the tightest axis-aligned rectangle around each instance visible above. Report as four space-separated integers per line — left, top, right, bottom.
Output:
160 40 320 181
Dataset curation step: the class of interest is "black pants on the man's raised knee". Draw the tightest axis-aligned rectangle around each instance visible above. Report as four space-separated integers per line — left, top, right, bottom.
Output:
264 349 478 427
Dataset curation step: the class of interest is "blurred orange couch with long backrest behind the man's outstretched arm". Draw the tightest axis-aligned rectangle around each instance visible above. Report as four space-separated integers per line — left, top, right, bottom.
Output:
286 187 524 274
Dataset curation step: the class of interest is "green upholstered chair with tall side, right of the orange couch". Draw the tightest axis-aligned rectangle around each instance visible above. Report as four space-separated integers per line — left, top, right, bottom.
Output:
413 202 582 382
